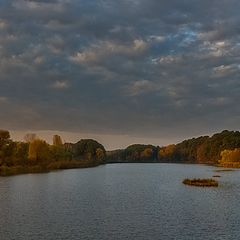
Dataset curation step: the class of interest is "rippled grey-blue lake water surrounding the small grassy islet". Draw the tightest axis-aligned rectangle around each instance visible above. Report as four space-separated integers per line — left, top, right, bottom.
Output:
0 164 240 240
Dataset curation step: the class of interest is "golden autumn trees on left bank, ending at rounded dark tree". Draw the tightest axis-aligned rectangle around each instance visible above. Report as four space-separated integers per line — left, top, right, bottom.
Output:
0 130 106 175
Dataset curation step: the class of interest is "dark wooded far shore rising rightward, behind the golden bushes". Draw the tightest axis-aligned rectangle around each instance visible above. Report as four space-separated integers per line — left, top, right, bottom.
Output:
107 130 240 164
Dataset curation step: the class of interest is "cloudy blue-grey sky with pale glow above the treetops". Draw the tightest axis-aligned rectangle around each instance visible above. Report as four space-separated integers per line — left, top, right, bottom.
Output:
0 0 240 149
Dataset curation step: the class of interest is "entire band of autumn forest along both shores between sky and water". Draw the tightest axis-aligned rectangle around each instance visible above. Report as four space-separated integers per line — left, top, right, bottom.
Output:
0 130 240 176
